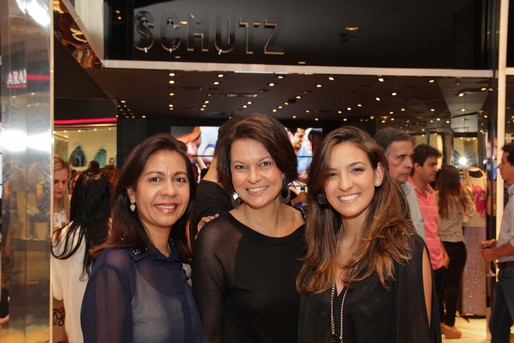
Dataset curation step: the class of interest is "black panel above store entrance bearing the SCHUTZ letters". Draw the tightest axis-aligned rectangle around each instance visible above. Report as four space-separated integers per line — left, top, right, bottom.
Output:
105 0 480 68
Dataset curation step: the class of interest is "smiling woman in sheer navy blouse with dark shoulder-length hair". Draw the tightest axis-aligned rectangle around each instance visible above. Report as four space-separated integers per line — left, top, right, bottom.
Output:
81 134 202 343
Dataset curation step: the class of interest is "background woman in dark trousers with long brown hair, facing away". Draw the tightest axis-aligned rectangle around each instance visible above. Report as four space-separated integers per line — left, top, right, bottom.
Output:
436 166 475 339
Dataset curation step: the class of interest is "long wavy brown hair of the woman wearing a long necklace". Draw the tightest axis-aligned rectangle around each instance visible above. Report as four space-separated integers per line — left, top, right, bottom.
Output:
297 126 414 293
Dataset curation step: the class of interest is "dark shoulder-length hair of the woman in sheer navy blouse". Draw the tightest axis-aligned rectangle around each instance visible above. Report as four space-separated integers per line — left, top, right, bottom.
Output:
92 133 196 259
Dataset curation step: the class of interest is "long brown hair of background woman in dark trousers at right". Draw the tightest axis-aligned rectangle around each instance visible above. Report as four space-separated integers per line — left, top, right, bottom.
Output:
436 165 466 218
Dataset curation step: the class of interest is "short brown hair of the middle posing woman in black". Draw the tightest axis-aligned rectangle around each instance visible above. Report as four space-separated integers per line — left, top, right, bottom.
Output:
216 113 298 194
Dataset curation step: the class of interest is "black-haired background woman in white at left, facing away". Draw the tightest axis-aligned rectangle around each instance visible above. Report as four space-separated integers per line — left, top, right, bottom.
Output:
51 172 109 343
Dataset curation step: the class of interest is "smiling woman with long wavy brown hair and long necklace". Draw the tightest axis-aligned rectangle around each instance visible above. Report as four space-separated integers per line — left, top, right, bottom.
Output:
297 126 441 343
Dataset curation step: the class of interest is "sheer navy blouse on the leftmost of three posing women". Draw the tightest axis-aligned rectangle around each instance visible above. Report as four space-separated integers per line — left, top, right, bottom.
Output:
81 248 202 343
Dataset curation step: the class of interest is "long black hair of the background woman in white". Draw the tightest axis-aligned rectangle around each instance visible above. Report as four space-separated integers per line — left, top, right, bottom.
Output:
51 172 109 278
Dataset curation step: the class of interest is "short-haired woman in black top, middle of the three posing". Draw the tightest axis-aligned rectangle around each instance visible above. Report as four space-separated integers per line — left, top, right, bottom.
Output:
192 114 304 343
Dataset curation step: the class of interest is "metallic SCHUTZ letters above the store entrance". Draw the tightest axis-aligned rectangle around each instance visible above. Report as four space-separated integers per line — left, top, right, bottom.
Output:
134 11 285 55
